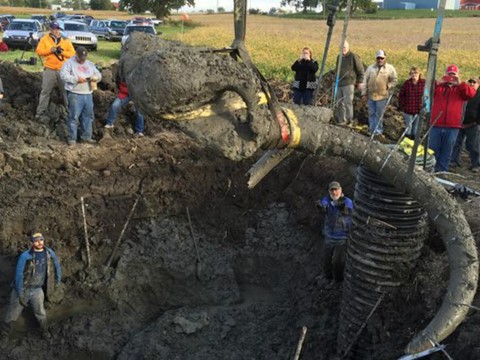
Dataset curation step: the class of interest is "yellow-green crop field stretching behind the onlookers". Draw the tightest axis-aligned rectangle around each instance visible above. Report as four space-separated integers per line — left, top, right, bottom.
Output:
0 7 480 81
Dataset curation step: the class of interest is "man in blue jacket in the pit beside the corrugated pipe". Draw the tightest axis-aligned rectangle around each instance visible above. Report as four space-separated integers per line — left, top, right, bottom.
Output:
317 181 353 282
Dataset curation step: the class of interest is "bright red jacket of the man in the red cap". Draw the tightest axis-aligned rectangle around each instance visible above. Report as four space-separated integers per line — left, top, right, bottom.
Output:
430 82 476 129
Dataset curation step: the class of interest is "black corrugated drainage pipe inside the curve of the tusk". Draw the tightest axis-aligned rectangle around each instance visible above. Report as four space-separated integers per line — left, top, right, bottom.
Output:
337 166 428 360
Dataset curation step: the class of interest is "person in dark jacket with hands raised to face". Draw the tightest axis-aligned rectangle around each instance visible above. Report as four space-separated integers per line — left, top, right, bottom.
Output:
292 47 318 105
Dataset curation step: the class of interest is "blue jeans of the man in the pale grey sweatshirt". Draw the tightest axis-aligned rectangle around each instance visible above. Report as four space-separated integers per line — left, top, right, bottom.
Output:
67 91 93 141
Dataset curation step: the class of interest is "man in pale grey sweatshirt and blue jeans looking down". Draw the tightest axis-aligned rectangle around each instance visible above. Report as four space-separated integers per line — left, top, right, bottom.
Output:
60 46 102 146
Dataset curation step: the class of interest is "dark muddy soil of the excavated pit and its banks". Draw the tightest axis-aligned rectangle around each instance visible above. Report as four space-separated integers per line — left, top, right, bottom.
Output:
0 62 480 360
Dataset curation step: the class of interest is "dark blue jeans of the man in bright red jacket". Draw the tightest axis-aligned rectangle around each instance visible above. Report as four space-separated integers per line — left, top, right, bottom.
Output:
428 126 458 172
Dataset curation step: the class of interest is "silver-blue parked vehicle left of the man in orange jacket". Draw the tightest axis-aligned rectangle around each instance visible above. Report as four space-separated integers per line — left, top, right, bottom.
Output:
3 19 43 49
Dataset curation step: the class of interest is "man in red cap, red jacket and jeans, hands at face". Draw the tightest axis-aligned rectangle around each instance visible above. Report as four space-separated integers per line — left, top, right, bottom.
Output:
428 64 476 172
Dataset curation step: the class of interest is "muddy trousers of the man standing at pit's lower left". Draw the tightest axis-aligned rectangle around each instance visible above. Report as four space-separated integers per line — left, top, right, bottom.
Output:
5 288 47 328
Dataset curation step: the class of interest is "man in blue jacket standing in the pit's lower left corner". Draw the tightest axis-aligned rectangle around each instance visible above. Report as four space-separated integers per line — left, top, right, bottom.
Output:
0 232 62 338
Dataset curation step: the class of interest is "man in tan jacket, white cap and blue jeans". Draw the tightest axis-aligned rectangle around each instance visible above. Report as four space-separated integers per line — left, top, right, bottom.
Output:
362 50 398 136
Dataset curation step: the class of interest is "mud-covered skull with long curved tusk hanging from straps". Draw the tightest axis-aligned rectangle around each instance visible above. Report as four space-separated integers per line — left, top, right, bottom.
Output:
120 36 478 354
